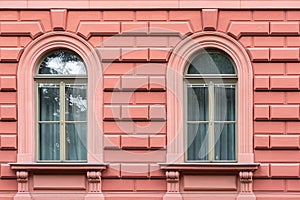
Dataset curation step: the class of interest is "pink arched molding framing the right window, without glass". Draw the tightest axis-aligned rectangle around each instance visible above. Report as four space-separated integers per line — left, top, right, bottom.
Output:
167 32 254 163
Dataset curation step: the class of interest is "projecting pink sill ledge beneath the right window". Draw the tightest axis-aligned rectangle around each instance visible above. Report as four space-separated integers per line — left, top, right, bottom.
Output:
159 163 259 174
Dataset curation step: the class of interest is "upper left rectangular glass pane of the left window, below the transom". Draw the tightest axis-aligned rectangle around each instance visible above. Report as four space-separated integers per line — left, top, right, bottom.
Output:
38 84 59 121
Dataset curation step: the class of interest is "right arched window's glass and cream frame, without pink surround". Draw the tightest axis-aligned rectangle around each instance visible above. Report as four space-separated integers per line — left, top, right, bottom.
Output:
184 48 237 162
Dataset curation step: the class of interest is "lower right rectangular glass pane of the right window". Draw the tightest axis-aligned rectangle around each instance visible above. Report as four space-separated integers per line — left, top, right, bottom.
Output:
215 123 236 160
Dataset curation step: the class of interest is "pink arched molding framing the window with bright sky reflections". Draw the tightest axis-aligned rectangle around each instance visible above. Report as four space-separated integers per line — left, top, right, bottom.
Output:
17 32 103 163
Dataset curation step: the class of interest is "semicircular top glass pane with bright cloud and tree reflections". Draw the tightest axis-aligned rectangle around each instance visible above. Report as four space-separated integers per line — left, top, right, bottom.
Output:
38 49 86 75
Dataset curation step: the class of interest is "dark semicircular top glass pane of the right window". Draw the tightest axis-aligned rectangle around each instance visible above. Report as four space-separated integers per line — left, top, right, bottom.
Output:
187 49 235 74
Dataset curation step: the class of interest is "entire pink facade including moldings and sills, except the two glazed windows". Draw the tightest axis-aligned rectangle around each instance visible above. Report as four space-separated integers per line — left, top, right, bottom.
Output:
0 0 300 200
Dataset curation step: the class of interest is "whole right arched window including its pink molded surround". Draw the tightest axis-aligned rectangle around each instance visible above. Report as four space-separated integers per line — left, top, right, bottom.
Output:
167 32 254 166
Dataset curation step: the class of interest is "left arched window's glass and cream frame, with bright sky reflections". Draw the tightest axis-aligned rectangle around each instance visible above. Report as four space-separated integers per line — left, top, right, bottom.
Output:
35 49 88 162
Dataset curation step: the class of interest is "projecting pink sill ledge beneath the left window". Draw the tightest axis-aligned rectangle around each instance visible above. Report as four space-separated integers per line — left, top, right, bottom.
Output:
9 163 108 171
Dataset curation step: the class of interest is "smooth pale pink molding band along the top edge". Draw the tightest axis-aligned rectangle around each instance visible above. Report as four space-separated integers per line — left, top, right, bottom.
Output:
0 0 300 10
